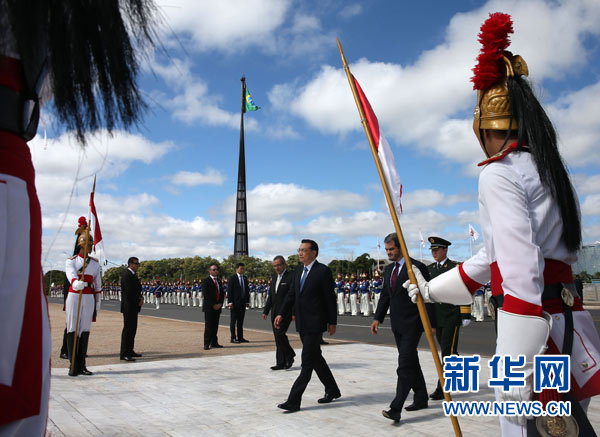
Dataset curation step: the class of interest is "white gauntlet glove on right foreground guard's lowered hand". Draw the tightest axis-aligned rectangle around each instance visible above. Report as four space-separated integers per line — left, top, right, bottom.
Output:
495 310 552 425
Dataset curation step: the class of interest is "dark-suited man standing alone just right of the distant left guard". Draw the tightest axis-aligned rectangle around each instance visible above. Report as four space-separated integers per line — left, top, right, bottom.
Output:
120 257 144 361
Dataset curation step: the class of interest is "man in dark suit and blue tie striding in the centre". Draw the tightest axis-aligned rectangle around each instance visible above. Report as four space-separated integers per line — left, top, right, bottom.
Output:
274 240 341 412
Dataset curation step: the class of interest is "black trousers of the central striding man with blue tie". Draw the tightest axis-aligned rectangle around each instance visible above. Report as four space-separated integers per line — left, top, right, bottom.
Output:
287 333 340 406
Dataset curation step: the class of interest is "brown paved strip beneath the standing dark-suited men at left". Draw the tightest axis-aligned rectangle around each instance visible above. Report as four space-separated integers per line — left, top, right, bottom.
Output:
48 303 336 367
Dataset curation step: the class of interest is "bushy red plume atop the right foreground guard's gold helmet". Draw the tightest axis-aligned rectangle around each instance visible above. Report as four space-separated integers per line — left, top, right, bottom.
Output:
471 12 513 90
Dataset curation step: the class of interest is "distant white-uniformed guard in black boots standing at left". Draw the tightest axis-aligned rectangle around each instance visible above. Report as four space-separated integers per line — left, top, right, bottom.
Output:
65 225 102 376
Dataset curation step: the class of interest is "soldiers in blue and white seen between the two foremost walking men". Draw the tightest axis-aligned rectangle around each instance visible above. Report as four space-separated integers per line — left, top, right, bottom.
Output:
335 270 383 317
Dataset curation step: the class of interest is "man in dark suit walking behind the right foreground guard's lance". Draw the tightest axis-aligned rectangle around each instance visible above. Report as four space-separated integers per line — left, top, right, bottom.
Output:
371 233 435 422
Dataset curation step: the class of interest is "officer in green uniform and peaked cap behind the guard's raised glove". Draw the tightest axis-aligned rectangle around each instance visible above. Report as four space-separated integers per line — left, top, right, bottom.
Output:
428 237 471 401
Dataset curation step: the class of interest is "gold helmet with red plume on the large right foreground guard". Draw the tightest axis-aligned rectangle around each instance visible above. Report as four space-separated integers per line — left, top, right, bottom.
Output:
471 12 529 158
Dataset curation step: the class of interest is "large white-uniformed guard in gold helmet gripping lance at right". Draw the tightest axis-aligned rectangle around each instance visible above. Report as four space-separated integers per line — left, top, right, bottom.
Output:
405 13 600 437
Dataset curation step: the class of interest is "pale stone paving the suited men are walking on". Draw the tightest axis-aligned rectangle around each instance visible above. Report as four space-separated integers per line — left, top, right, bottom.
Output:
48 344 600 437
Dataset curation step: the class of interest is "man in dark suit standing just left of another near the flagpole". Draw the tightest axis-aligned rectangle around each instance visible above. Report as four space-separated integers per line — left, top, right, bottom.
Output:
202 264 225 350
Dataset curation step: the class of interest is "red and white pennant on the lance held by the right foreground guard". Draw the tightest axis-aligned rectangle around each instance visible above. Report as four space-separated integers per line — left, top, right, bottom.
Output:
352 75 402 214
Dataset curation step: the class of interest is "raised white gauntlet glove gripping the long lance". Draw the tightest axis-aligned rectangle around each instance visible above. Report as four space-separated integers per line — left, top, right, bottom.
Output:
402 267 473 305
